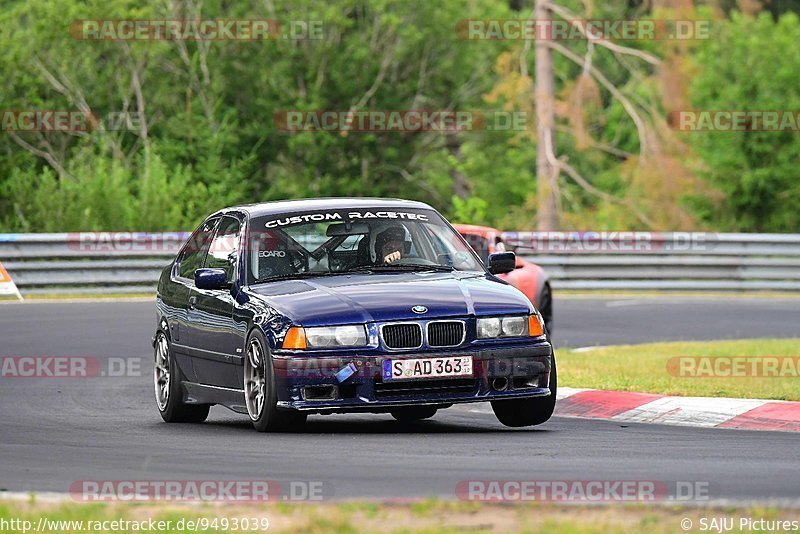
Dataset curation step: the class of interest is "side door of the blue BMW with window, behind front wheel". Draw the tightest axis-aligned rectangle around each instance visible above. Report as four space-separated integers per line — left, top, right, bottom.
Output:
188 215 242 388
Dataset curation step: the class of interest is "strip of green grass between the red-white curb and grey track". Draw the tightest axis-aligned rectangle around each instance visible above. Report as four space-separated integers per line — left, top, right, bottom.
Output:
556 339 800 401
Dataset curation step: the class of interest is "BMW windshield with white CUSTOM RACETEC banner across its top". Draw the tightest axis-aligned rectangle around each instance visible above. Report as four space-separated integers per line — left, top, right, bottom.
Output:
246 208 484 283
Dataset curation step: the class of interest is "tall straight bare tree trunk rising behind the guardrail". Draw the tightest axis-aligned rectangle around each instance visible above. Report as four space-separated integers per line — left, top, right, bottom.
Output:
533 0 558 231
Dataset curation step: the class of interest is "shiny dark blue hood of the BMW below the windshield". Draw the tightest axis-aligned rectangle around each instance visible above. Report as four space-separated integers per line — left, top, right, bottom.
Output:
250 273 531 326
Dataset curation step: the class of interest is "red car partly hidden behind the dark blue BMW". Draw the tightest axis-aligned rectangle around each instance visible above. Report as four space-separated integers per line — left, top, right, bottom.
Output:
453 224 553 333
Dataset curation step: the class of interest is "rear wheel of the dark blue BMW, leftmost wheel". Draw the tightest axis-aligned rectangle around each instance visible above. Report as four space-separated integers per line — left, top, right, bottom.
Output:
153 330 210 423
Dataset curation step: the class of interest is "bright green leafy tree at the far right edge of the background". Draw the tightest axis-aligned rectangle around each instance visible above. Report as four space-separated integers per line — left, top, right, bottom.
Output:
689 13 800 232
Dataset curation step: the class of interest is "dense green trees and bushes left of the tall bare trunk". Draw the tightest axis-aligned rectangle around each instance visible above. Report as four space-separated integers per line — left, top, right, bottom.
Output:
0 0 507 231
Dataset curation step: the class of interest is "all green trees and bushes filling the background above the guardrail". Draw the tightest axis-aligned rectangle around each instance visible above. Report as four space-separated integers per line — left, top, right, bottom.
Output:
0 0 800 232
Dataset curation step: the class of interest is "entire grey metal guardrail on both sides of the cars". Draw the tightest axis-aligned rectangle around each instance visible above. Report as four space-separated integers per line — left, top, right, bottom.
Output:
0 232 800 295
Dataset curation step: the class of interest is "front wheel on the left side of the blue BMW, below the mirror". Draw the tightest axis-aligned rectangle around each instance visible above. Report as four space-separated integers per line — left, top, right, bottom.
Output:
244 330 306 432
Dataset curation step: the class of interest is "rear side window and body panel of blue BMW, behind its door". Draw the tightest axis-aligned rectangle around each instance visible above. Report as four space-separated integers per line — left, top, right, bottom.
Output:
169 217 219 382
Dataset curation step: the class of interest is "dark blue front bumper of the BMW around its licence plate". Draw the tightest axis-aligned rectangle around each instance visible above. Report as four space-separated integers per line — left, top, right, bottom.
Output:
273 340 553 413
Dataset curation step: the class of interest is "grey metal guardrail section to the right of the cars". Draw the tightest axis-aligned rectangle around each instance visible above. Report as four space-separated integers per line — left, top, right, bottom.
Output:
503 232 800 291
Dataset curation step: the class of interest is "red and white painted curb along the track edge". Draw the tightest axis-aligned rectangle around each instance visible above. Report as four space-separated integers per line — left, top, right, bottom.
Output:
555 388 800 432
